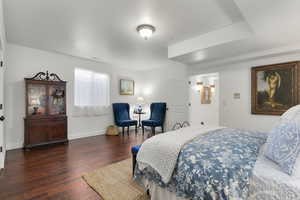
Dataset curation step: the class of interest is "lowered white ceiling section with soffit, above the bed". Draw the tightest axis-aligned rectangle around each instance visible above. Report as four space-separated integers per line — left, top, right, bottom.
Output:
169 0 300 67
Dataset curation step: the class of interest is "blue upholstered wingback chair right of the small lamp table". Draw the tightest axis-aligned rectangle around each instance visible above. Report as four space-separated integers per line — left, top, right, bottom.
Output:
142 103 167 135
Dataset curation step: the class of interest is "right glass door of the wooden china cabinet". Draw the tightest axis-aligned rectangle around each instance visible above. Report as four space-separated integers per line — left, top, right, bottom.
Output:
49 85 66 115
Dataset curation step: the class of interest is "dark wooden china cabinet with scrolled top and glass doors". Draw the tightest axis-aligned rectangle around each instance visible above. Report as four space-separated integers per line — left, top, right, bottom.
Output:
24 71 68 149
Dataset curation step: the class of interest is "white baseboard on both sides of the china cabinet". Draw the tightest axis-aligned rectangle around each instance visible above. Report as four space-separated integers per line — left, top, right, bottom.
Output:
6 130 105 150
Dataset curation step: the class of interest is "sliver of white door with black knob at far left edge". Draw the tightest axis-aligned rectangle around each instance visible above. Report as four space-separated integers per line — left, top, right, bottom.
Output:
0 51 5 169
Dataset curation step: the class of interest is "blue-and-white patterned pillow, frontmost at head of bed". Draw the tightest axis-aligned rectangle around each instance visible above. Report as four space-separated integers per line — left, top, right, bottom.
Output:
264 120 300 175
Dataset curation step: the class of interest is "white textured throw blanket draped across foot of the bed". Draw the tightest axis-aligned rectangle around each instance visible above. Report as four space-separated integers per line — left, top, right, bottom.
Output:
137 126 221 183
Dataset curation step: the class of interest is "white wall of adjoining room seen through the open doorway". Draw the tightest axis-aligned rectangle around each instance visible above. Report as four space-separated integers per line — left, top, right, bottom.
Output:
189 74 220 126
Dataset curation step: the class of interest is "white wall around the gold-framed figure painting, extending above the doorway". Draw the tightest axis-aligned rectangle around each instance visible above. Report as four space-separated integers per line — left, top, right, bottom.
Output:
188 54 300 131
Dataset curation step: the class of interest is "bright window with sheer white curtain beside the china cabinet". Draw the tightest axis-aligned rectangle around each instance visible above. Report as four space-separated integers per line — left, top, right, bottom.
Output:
75 68 110 107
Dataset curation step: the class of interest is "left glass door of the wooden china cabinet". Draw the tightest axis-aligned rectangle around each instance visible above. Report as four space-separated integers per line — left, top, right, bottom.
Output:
27 84 47 116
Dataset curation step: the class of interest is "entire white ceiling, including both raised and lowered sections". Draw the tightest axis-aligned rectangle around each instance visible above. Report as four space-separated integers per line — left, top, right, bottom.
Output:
4 0 300 70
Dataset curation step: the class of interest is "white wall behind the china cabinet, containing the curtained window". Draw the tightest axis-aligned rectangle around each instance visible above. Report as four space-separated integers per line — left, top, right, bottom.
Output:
5 44 145 149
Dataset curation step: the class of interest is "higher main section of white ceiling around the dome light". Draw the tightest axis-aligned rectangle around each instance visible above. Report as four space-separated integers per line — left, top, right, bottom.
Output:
4 0 242 70
